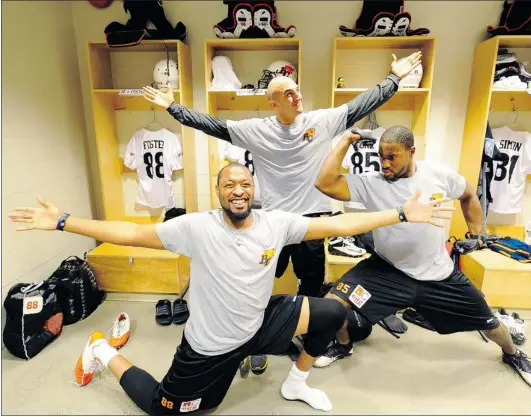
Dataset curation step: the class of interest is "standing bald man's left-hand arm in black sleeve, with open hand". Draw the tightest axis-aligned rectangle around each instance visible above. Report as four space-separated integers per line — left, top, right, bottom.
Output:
143 87 231 142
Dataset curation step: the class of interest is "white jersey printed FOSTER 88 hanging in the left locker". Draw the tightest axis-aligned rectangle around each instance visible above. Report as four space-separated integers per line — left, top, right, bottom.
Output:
124 129 183 209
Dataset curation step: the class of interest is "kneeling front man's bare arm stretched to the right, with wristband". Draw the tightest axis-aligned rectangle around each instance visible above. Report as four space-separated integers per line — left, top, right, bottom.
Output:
303 191 455 240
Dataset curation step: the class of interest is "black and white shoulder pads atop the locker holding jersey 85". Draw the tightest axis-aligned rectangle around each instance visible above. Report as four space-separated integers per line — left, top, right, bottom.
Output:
339 0 430 37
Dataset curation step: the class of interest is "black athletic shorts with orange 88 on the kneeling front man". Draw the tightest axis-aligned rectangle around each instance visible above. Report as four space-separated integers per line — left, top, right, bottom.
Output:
151 295 304 415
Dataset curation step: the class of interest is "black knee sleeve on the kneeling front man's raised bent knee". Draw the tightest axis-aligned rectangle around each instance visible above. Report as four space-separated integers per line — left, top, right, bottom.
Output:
304 297 347 357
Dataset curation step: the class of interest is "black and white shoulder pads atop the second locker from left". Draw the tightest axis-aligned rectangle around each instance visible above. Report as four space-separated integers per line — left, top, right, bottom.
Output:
214 0 297 39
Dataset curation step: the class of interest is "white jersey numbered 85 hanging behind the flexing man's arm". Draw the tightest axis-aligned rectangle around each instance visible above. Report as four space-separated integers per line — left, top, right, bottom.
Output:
332 127 385 210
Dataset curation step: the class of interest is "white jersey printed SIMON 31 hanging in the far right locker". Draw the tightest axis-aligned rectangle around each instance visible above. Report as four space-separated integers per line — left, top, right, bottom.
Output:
489 126 531 214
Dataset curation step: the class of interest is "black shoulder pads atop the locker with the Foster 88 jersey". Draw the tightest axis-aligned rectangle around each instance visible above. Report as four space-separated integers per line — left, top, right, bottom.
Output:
104 0 186 47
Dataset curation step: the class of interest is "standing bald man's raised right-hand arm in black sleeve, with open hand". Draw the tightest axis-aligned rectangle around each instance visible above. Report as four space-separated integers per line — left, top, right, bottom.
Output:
347 52 422 126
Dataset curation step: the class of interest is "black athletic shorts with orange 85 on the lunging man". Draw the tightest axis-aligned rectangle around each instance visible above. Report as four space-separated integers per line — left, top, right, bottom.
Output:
330 254 499 334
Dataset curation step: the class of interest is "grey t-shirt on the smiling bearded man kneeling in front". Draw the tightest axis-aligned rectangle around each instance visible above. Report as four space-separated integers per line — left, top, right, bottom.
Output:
157 209 311 356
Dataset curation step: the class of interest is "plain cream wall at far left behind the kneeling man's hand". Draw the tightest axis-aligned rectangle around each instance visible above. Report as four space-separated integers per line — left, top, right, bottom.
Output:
2 1 95 299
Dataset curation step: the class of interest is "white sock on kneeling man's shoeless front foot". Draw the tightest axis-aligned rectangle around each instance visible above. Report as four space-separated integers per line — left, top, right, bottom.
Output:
280 364 332 411
